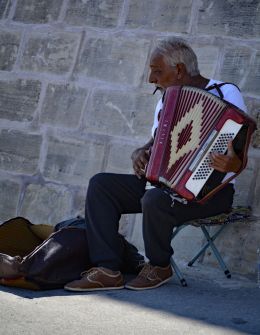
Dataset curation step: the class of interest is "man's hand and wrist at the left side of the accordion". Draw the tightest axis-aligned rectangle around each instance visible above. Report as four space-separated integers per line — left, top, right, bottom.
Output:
131 138 154 178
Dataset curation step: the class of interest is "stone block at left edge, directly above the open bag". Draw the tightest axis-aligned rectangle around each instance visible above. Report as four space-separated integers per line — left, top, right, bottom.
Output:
0 180 20 223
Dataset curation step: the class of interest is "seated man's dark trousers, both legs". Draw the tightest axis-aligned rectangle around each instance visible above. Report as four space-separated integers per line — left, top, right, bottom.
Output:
86 173 234 270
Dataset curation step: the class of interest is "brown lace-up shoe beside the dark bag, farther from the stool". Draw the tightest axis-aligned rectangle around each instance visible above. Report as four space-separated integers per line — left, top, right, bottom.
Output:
64 267 124 291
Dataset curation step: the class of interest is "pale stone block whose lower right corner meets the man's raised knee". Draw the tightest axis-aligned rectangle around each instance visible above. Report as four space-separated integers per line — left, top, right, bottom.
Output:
43 137 105 185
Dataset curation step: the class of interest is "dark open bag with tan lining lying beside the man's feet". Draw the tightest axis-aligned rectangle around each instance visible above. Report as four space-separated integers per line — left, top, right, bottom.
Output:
0 217 144 290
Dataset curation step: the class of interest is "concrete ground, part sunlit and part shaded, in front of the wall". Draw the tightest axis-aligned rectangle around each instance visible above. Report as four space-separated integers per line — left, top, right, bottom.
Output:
0 265 260 335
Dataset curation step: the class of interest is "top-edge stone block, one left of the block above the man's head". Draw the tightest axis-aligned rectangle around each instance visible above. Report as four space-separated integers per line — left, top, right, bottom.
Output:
65 0 123 28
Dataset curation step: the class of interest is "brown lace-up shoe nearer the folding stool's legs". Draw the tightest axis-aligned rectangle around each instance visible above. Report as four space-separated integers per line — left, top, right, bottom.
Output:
125 264 172 291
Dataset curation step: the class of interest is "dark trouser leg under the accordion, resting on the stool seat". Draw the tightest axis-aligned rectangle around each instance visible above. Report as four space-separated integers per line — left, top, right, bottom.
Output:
142 185 234 266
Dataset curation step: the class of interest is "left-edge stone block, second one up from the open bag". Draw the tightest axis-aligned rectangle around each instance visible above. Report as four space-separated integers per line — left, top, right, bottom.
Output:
0 129 42 174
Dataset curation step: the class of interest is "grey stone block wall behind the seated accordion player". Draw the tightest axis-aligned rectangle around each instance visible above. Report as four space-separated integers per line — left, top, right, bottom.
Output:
0 0 260 273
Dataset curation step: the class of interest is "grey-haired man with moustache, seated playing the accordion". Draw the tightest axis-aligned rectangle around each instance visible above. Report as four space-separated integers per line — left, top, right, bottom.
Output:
65 38 245 291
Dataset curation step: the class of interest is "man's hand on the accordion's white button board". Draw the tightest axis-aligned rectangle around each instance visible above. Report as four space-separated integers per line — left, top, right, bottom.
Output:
210 141 242 172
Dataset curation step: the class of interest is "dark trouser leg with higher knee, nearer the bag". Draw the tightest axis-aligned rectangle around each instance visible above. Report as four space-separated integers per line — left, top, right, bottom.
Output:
86 173 146 270
